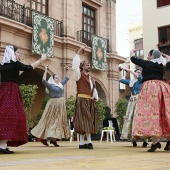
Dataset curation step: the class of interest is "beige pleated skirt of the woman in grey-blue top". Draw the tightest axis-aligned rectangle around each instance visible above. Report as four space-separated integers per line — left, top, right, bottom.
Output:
31 97 70 139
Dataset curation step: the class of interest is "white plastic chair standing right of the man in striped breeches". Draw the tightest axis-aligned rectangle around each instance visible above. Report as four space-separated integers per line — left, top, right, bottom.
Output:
100 120 116 143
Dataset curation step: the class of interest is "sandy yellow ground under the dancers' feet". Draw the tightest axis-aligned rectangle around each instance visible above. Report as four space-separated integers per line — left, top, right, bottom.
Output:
0 141 170 170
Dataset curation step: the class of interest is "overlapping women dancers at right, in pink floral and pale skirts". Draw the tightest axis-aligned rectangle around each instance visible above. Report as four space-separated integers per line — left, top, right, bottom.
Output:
120 50 170 152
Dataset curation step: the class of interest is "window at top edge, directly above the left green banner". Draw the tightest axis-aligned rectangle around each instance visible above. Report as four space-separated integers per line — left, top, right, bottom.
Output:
29 0 48 15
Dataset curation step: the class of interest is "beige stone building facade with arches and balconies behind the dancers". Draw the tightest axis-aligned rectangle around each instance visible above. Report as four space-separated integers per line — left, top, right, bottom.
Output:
0 0 125 116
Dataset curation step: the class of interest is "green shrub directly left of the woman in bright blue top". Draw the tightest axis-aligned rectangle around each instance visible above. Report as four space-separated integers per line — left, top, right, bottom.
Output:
115 98 128 131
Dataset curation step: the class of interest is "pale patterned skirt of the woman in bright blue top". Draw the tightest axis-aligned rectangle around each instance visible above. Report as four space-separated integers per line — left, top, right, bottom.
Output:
120 95 138 139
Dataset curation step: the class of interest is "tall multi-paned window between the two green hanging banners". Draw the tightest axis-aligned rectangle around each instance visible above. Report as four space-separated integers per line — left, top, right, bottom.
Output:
82 5 95 41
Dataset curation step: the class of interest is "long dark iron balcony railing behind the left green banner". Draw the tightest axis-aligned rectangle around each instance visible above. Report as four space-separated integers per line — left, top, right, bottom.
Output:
0 0 64 37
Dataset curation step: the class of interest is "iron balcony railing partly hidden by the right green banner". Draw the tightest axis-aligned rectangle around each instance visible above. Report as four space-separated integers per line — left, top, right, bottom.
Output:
77 30 111 53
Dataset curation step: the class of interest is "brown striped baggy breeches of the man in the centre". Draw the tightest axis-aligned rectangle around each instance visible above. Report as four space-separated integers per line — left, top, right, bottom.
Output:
74 97 97 134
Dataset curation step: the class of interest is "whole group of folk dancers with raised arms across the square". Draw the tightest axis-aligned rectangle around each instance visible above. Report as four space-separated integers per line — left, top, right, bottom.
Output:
0 46 170 154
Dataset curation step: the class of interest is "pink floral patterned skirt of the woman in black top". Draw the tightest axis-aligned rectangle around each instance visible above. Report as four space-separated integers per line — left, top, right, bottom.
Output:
133 80 170 138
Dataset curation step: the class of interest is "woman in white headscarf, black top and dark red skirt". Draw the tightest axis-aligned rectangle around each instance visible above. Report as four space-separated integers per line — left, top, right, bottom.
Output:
0 46 47 154
